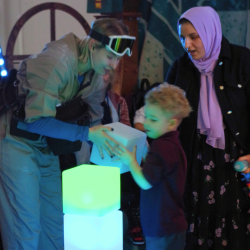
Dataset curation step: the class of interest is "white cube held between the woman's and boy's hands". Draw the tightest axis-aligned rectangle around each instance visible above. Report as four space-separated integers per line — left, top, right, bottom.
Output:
90 122 147 174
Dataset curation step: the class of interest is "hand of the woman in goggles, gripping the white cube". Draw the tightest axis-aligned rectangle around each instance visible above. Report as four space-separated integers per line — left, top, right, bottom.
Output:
89 126 118 159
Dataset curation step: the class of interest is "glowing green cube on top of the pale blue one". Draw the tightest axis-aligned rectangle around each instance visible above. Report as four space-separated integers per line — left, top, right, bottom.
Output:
62 165 121 216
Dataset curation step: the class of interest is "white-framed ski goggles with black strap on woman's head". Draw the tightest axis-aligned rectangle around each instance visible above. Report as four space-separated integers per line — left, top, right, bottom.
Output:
89 29 135 56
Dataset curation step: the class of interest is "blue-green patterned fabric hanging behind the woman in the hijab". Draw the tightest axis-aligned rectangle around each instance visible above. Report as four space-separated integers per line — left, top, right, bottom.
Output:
138 0 250 84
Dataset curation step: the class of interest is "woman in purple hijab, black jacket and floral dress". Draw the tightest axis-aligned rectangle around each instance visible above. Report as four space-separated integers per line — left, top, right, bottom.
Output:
166 7 250 250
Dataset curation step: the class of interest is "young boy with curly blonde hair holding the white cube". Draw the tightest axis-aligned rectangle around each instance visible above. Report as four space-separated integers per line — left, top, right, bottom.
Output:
115 83 191 250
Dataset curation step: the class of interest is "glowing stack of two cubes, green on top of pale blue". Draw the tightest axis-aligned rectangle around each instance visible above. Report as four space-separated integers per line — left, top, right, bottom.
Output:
62 165 123 250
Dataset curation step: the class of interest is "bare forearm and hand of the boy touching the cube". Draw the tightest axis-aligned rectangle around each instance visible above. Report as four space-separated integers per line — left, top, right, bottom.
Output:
115 145 152 189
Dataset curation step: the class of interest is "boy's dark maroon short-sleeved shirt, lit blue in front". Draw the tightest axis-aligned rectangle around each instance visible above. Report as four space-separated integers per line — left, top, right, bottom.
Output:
140 131 187 237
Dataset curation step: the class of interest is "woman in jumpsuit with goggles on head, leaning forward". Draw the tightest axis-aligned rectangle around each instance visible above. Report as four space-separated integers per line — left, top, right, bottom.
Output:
0 19 134 250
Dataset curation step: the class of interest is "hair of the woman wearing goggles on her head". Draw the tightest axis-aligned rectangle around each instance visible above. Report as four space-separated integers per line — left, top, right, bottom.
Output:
77 18 128 63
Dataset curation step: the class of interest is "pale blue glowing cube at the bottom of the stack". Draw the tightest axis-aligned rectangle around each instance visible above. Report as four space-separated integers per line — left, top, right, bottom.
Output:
64 211 123 250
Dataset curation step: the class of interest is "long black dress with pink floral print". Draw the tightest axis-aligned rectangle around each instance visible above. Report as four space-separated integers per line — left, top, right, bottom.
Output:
184 129 250 250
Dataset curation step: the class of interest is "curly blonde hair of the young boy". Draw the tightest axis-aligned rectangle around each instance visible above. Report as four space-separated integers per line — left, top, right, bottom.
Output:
145 82 192 119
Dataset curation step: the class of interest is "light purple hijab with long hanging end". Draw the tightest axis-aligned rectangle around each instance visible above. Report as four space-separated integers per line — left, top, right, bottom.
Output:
177 7 225 149
